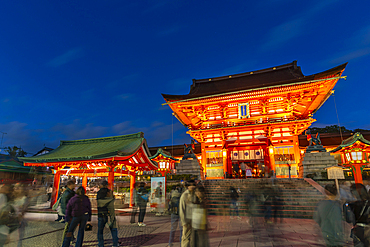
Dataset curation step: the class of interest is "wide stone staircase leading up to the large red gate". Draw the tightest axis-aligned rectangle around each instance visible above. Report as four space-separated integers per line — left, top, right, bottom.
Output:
203 178 324 218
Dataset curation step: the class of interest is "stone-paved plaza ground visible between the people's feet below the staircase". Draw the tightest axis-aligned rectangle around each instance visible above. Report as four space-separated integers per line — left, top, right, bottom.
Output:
6 213 353 247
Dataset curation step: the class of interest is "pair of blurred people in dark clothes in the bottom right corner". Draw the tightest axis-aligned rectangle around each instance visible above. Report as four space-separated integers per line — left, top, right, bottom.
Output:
314 182 370 247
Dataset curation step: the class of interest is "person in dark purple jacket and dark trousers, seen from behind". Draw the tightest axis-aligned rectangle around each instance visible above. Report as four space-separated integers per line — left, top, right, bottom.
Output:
62 186 91 247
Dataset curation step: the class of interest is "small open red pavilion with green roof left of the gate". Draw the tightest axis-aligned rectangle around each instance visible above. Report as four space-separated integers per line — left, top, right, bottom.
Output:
19 132 158 205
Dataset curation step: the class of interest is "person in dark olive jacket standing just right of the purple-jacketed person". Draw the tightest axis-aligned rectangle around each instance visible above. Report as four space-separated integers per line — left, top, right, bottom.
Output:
96 180 119 247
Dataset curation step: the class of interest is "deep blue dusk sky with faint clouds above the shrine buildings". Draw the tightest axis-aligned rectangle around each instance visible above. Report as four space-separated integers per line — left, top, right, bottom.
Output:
0 0 370 153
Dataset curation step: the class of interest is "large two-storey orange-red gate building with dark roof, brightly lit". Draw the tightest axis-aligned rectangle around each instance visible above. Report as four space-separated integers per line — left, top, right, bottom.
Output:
162 61 347 179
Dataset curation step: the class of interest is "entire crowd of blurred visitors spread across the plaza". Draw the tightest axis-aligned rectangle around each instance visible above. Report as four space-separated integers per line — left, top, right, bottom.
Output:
0 180 370 247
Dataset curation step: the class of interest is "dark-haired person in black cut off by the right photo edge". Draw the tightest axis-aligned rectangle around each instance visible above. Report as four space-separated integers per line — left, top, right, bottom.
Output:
345 183 370 247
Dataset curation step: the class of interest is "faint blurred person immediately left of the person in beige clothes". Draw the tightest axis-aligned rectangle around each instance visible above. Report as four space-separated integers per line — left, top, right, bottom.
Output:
168 187 182 247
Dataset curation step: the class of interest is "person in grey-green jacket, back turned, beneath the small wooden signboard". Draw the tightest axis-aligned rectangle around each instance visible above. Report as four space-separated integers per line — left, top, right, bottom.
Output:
314 184 345 246
